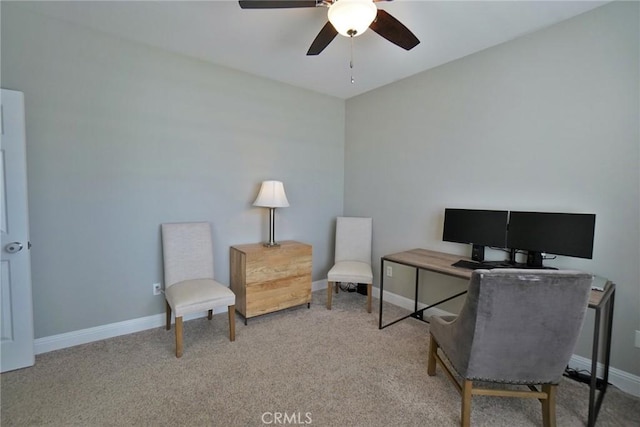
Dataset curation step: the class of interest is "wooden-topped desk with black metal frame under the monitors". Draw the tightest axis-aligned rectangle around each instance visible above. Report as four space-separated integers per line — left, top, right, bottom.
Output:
378 249 616 427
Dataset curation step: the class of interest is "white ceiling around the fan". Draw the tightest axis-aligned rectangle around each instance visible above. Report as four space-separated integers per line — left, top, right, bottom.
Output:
18 0 608 99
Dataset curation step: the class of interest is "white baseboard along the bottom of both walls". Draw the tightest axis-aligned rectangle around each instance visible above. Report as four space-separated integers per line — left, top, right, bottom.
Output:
34 279 640 397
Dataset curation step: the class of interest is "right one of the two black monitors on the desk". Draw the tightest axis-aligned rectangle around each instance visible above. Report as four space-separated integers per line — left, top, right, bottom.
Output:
507 211 596 259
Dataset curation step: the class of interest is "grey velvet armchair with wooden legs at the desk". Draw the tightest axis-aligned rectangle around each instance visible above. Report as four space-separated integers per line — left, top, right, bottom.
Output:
427 269 592 426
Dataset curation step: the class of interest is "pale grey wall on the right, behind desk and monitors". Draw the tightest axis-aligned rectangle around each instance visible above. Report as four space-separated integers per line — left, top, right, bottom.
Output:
345 2 640 375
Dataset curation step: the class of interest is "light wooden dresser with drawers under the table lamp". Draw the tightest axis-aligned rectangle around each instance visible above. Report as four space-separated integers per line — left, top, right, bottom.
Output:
229 240 312 324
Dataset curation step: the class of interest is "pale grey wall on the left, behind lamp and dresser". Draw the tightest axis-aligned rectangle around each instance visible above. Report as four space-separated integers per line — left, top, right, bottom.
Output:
1 2 344 338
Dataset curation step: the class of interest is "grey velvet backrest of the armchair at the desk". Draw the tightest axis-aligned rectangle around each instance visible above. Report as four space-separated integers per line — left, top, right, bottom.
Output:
460 269 592 384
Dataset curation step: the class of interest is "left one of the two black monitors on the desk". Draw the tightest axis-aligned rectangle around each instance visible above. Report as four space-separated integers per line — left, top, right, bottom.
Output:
442 208 508 248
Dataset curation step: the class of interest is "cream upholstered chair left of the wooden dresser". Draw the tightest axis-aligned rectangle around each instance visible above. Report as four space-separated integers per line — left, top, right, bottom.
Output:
161 222 236 357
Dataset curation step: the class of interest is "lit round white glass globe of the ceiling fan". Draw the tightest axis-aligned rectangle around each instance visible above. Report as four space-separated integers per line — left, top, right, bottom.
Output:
327 0 378 37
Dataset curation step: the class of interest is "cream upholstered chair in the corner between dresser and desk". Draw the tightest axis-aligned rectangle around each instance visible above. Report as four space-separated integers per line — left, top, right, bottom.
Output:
327 217 373 313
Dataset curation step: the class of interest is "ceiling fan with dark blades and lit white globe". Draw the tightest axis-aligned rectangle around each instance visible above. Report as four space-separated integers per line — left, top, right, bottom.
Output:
238 0 420 55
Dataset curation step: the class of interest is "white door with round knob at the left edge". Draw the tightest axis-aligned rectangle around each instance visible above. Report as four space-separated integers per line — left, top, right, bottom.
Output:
0 89 35 372
